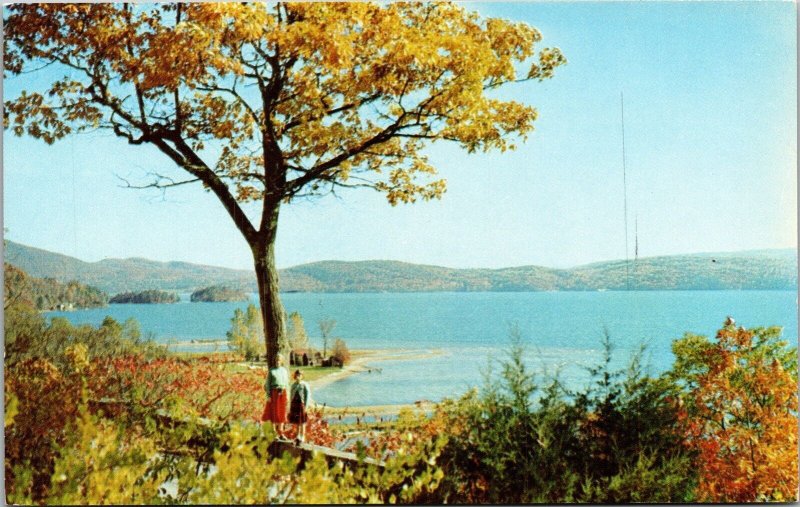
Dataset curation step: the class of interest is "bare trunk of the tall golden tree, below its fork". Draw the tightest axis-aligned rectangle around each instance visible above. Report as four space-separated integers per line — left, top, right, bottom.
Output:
255 204 286 368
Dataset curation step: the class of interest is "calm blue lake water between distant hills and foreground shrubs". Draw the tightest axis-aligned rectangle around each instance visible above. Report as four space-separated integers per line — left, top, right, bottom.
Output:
48 291 797 406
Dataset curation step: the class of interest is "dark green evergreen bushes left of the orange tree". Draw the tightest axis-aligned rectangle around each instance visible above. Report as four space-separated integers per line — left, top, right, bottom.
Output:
434 334 695 503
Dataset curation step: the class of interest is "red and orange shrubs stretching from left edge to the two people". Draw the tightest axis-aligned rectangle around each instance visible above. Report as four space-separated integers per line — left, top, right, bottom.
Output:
5 332 340 503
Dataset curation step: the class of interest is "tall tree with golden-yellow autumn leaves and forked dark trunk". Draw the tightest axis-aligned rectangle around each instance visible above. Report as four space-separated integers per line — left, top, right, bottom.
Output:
4 2 565 365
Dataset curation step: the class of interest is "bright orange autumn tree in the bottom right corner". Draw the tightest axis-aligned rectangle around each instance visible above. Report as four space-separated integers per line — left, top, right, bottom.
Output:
672 318 798 503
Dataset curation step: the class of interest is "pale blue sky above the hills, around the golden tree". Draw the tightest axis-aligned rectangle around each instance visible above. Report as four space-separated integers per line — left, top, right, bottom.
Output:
3 1 797 269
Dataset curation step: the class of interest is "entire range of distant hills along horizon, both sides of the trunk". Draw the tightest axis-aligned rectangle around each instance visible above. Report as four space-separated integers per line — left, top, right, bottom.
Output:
5 241 797 293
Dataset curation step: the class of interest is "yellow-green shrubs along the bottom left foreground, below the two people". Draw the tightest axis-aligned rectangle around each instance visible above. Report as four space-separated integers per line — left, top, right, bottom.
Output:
14 386 443 505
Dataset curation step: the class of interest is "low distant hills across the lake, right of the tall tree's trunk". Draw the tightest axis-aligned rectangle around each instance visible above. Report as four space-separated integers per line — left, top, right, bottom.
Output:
281 254 797 292
